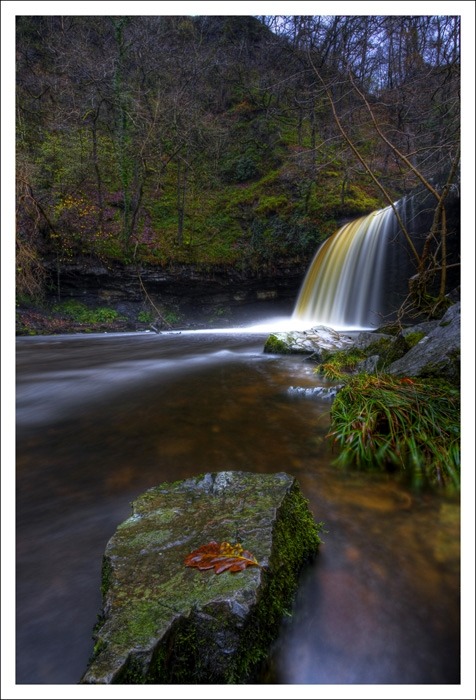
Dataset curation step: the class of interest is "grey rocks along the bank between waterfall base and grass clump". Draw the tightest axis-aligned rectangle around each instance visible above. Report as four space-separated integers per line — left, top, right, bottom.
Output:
264 302 461 384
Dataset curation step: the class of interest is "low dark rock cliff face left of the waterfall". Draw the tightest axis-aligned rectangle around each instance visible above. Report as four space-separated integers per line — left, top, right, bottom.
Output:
41 259 306 325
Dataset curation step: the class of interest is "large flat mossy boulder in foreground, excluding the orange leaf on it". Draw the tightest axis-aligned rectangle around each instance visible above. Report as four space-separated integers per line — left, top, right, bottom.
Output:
80 471 320 684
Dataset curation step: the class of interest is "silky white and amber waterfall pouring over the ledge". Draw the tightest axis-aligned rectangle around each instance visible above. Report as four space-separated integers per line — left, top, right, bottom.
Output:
293 202 408 330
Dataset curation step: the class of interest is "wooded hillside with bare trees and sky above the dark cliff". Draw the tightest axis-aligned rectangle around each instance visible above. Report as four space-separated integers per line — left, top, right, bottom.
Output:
16 16 460 314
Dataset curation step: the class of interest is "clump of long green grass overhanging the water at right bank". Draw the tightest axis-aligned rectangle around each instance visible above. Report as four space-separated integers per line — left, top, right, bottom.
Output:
328 373 460 491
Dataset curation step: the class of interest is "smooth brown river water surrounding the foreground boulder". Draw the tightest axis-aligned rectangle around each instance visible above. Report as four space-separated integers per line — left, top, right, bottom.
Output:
16 330 460 684
